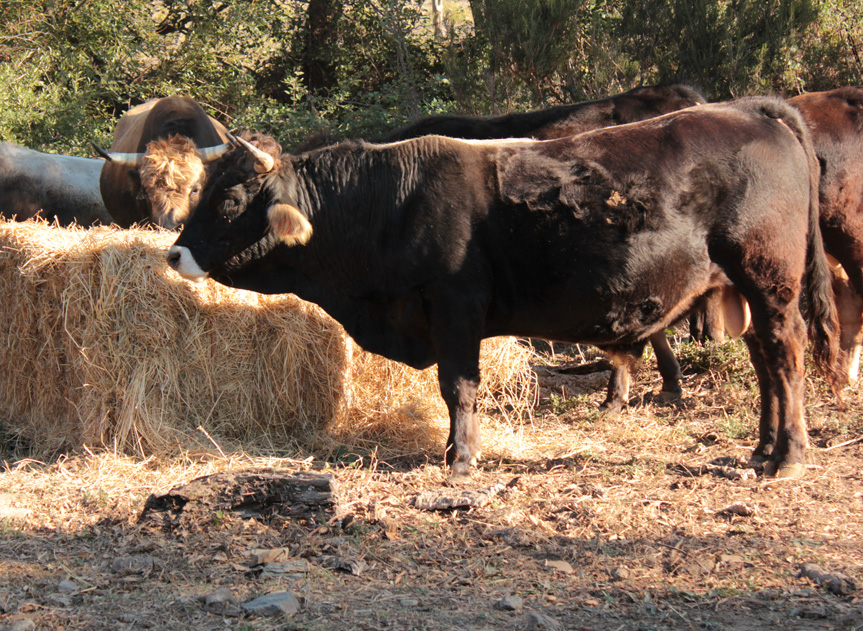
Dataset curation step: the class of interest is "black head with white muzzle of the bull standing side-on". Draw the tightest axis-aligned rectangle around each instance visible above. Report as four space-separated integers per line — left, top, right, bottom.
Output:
168 135 312 281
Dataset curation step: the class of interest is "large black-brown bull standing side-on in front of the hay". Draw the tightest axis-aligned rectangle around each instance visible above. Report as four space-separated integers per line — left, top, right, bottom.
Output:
168 98 841 476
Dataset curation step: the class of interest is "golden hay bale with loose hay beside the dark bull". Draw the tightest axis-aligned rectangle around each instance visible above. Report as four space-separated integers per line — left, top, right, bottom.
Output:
0 221 534 456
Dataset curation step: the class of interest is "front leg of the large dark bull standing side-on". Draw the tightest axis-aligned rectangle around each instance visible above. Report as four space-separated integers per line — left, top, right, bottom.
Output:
438 361 480 481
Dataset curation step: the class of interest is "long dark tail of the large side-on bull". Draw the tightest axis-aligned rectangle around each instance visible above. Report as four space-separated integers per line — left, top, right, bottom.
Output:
794 118 848 400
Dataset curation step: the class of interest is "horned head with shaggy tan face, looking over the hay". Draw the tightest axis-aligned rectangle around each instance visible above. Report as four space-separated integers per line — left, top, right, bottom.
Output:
96 135 232 230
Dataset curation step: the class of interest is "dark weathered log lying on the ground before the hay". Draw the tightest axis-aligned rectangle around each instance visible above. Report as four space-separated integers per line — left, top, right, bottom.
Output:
139 469 338 528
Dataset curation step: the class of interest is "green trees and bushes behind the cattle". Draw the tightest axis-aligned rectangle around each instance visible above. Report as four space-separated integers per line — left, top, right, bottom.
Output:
0 0 863 157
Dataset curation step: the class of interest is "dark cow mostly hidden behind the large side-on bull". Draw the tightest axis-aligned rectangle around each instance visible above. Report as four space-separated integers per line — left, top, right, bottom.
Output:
378 84 707 411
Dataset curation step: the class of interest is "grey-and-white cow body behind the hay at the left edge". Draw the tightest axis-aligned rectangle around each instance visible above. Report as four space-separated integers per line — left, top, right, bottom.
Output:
0 142 111 226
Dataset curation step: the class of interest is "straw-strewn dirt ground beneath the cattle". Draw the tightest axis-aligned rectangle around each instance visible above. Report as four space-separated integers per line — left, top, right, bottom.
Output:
0 343 863 631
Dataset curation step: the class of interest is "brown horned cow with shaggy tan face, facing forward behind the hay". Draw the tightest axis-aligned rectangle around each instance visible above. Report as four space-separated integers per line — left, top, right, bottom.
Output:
96 96 230 229
